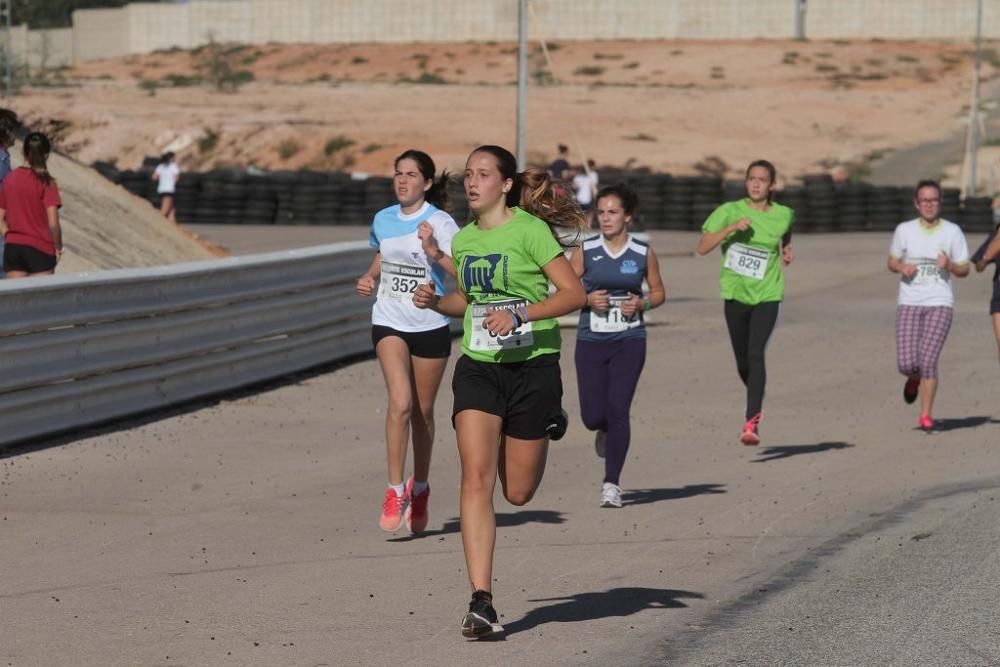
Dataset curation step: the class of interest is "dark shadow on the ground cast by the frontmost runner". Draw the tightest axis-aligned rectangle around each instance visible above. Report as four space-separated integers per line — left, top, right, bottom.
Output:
503 588 705 636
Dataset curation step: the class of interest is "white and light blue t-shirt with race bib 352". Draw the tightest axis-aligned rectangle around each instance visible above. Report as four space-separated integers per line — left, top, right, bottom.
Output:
368 202 458 331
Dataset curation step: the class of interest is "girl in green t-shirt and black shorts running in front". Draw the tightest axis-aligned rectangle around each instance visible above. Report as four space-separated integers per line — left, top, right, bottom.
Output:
413 146 587 637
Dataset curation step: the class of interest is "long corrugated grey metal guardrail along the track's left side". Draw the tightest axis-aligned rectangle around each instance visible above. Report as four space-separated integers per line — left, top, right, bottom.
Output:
0 242 390 445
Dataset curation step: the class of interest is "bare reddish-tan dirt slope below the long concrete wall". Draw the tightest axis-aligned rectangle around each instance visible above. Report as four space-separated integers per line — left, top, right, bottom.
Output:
15 41 1000 187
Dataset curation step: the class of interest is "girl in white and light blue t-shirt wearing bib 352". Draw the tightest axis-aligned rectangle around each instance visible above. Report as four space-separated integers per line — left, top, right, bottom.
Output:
356 149 458 534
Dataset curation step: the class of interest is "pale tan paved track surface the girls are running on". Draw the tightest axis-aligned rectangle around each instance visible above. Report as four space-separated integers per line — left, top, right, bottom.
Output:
0 232 998 667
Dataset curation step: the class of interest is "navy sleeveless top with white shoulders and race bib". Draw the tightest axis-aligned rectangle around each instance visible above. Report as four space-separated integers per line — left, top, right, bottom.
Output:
576 236 649 343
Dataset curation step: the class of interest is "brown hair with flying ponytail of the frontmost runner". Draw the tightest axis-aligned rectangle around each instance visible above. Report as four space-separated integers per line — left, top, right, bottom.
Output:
470 145 589 248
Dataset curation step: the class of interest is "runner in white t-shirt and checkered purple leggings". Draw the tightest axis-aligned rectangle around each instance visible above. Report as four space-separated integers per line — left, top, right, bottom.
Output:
888 181 970 432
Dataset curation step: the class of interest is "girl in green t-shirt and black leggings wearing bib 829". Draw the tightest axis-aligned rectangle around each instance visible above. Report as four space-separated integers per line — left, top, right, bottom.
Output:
698 160 795 445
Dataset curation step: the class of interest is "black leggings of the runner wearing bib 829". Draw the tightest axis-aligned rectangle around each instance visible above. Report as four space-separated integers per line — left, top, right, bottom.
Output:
725 299 781 419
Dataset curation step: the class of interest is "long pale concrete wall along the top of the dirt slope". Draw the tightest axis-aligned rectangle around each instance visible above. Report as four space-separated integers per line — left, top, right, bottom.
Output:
13 0 1000 62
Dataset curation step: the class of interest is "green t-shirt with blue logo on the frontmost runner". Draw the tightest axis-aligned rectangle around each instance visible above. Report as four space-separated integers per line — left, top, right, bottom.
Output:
451 208 562 362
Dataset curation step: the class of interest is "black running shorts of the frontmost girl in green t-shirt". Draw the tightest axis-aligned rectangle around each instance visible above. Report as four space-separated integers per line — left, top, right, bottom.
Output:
451 354 562 440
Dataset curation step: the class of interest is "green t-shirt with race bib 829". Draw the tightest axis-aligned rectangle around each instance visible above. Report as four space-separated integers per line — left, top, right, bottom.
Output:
701 199 795 306
